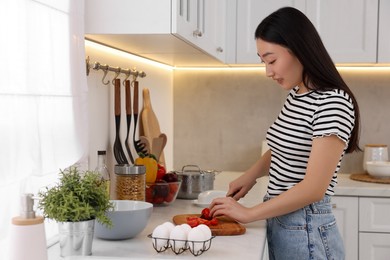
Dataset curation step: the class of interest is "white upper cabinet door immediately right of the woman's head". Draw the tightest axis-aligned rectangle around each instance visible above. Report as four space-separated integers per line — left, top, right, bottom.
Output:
306 0 378 63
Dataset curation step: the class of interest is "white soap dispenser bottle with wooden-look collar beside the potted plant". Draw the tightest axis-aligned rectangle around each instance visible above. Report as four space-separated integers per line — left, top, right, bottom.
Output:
7 193 48 260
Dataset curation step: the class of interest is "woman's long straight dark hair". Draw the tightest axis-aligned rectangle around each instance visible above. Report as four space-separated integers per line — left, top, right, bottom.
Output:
255 7 361 153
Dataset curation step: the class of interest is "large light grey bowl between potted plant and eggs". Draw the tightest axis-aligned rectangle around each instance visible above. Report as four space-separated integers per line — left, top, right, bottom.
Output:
95 200 153 240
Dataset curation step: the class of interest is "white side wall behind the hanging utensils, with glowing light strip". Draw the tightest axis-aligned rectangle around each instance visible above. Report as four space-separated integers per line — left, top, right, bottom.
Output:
86 41 173 178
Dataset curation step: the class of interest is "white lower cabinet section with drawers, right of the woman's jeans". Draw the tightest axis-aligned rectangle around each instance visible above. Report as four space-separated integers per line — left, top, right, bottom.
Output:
332 196 390 260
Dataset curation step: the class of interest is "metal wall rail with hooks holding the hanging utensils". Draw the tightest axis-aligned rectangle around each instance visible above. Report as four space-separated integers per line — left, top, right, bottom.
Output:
85 57 146 85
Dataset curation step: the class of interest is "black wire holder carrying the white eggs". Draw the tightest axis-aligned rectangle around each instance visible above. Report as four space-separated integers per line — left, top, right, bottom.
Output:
148 234 215 256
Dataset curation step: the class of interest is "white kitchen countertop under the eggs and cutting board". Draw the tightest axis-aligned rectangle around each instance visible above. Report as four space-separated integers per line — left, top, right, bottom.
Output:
48 172 390 260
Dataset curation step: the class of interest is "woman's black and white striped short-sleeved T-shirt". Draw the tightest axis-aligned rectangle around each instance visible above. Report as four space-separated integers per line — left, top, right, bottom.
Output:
267 87 355 197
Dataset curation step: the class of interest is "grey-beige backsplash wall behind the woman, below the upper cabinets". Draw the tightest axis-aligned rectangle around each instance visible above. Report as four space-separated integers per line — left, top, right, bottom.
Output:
173 69 390 173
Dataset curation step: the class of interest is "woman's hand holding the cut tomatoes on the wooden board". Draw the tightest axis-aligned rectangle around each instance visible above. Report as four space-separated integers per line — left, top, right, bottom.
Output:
210 197 251 223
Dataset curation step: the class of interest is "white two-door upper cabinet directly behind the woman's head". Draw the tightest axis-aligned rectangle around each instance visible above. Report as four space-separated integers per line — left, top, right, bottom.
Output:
230 0 380 64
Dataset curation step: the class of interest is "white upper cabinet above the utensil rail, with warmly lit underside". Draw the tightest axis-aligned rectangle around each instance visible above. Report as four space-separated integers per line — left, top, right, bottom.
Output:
85 0 227 66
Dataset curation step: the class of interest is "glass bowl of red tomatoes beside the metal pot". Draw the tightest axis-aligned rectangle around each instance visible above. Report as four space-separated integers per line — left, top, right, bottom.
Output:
145 173 181 206
